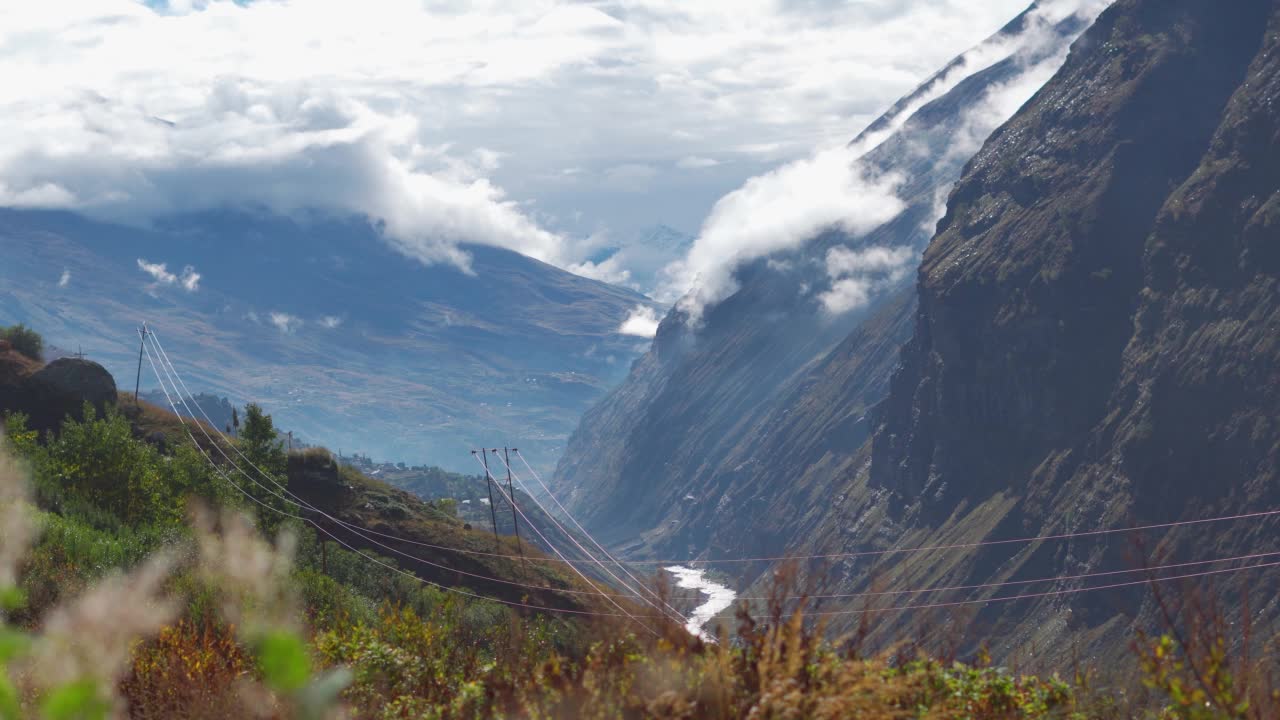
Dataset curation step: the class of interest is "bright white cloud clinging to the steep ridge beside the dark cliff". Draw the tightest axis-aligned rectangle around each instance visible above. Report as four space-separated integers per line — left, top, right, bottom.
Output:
658 0 1108 323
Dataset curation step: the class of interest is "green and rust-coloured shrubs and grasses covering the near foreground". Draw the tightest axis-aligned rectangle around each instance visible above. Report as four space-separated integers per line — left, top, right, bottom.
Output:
0 327 1280 720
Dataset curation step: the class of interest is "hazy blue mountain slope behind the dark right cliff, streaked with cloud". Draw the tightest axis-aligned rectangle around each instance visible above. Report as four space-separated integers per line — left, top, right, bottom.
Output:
557 0 1087 557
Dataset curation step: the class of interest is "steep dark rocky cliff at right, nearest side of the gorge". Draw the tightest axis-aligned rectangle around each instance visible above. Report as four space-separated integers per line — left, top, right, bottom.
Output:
768 0 1280 666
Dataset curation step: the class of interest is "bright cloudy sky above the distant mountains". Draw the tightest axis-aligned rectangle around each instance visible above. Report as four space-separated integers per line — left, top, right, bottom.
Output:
0 0 1097 297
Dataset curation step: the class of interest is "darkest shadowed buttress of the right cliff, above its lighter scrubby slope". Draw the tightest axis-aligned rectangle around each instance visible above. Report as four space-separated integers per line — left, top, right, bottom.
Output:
872 3 1268 512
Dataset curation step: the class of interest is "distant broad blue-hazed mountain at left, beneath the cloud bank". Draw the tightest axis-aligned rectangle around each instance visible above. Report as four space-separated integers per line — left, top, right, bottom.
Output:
0 209 652 470
